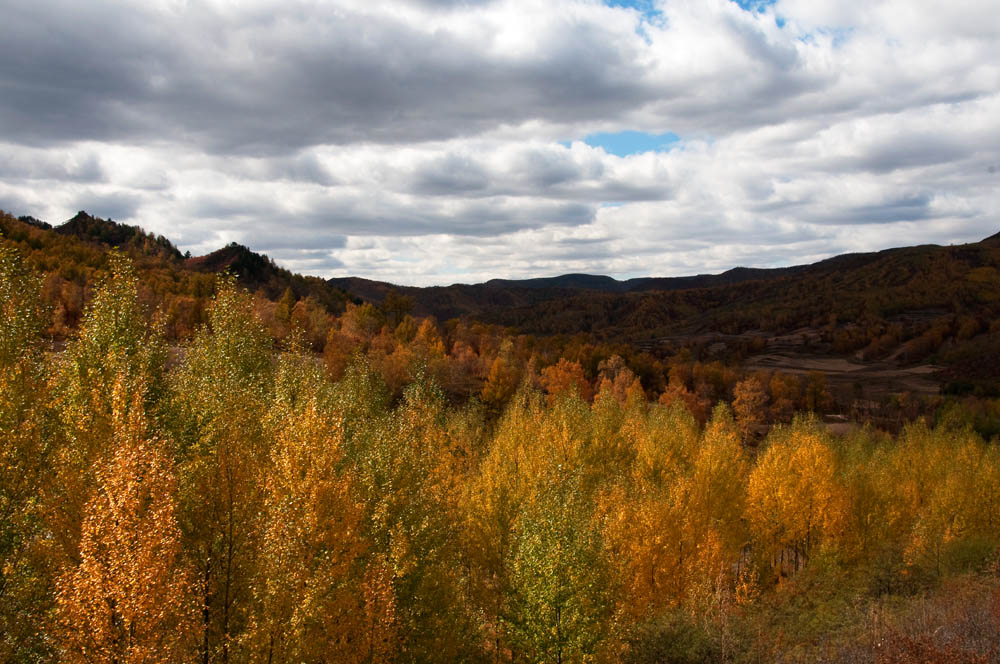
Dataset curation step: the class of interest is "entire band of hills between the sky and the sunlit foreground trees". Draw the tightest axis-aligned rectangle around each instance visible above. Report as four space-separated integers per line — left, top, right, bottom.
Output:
0 212 1000 394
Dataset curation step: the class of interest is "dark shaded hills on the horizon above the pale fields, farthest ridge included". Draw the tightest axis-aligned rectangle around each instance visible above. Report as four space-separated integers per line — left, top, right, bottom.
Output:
329 234 1000 339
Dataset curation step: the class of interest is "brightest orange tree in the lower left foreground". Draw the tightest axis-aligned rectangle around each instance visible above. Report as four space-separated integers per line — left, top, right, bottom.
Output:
56 378 197 664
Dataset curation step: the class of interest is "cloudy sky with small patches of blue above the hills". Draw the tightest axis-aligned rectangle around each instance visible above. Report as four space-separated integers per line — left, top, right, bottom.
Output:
0 0 1000 285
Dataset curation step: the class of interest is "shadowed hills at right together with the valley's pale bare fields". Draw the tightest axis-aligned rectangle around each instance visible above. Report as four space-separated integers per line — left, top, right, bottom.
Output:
331 234 1000 403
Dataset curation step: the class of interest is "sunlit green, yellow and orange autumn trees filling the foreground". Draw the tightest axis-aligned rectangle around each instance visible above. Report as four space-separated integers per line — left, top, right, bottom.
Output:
0 247 1000 662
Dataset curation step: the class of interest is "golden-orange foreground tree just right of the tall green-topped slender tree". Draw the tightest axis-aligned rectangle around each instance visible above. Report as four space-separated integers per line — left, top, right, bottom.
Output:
244 353 378 663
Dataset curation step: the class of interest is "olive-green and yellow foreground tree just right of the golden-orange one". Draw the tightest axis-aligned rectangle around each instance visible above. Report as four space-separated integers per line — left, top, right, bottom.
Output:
344 376 483 661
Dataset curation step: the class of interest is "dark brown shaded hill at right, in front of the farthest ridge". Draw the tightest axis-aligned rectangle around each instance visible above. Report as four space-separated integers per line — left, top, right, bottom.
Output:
486 241 1000 339
